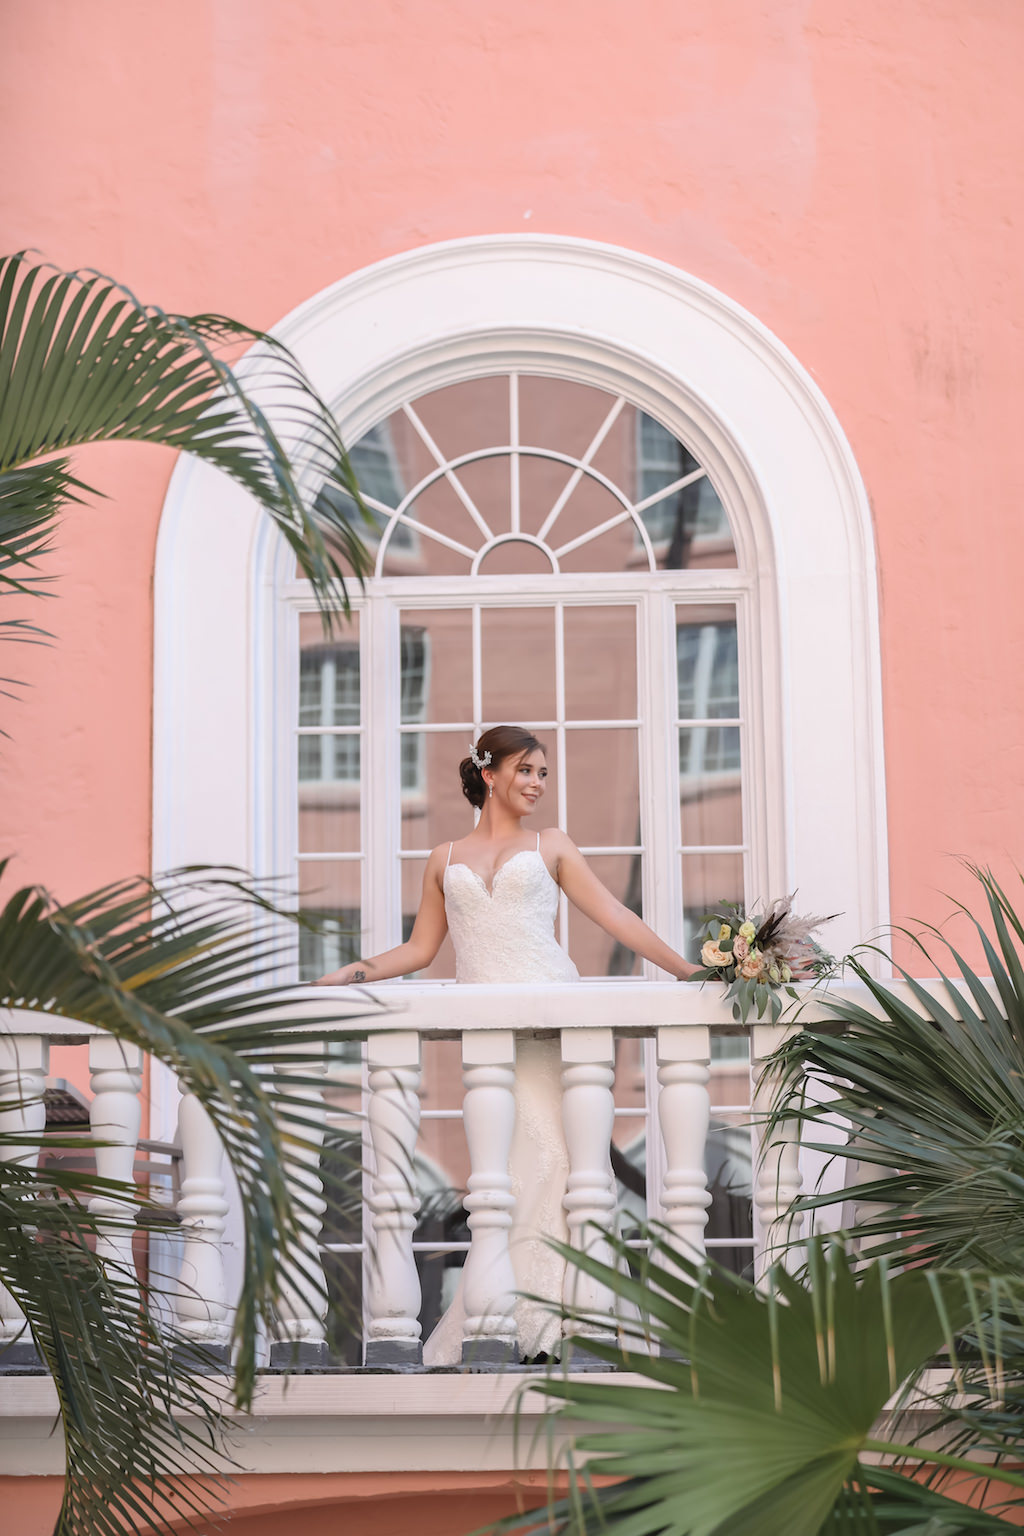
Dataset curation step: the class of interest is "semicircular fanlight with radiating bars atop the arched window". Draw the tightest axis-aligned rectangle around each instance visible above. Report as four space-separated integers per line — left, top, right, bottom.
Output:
328 375 737 578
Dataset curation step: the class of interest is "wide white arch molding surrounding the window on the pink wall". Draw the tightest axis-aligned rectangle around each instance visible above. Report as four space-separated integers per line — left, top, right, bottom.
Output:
154 235 887 995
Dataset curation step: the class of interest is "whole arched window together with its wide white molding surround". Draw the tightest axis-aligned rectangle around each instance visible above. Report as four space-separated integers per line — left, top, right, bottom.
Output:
154 237 887 995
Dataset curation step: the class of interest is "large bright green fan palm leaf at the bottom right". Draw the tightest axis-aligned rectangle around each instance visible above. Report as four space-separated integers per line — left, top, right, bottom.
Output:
494 1238 1024 1536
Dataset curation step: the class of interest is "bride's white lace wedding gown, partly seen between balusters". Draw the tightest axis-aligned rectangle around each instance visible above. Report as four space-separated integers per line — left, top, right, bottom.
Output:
424 834 579 1366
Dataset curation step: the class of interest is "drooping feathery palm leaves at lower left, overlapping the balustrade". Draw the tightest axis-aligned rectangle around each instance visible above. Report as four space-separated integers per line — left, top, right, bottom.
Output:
0 865 376 1536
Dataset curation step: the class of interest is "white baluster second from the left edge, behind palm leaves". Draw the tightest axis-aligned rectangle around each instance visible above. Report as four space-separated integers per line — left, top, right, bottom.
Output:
89 1035 143 1293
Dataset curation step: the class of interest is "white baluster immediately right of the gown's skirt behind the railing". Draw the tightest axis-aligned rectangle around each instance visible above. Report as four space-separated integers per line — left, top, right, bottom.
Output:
562 1029 617 1349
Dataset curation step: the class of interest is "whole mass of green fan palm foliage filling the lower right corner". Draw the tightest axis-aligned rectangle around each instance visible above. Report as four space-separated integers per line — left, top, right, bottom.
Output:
494 871 1024 1536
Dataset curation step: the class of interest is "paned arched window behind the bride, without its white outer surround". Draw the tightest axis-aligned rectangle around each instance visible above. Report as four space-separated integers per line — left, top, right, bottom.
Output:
288 370 752 980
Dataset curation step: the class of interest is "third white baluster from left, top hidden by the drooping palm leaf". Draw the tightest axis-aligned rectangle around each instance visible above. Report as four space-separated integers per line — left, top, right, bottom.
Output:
173 1094 232 1361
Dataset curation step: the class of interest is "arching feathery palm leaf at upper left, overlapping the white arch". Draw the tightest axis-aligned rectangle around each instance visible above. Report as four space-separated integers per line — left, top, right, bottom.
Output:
0 255 372 632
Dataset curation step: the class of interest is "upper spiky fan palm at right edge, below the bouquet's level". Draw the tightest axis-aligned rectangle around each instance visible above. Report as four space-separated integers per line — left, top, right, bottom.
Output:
769 871 1024 1273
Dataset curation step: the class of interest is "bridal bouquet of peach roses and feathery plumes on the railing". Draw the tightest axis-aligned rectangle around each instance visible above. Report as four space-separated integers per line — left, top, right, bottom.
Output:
694 892 838 1023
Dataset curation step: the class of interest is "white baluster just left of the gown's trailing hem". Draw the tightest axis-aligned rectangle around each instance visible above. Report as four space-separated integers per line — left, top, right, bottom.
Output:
365 1029 422 1366
